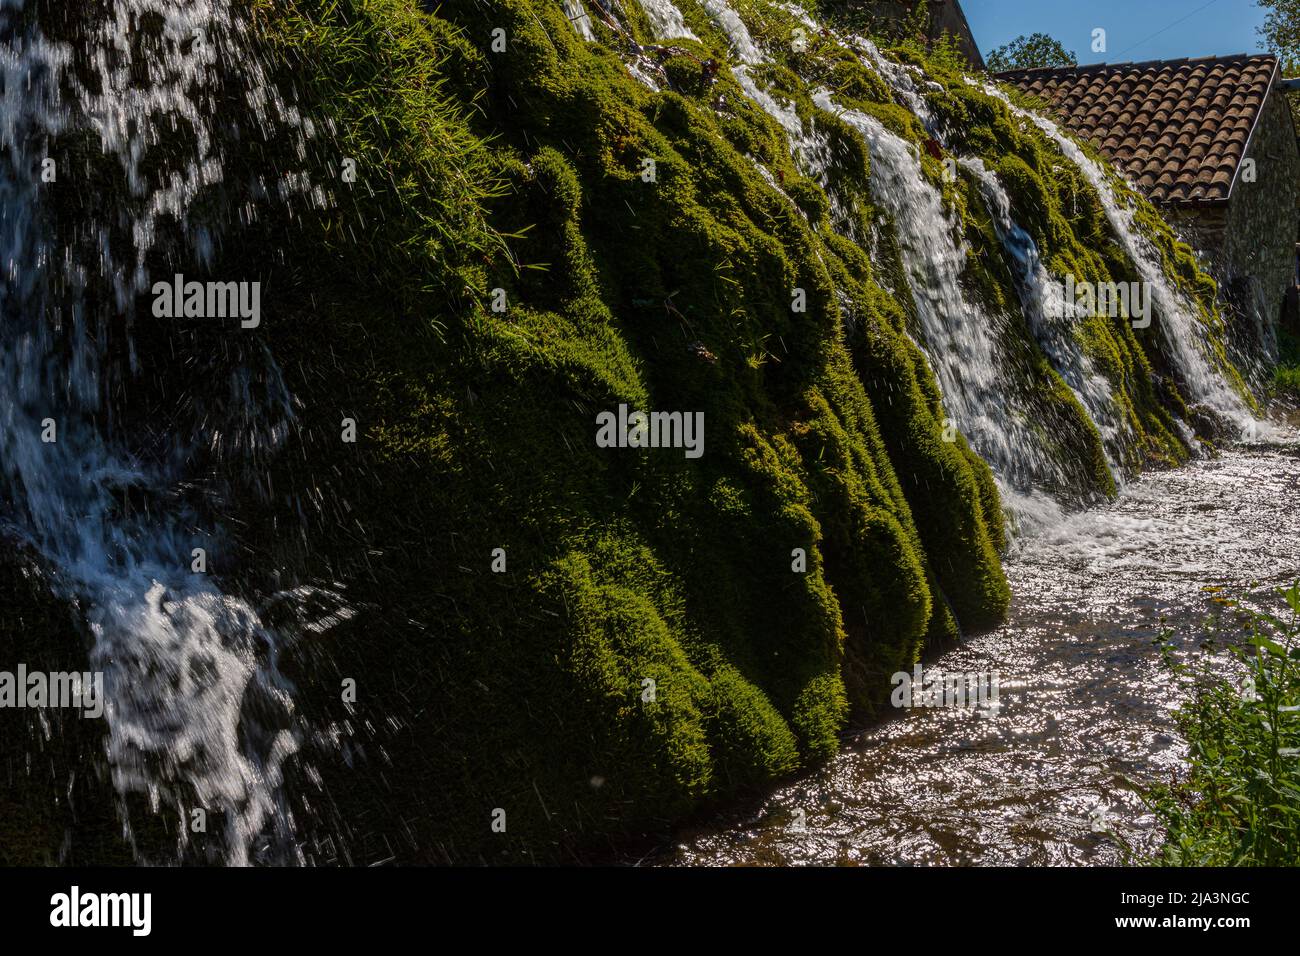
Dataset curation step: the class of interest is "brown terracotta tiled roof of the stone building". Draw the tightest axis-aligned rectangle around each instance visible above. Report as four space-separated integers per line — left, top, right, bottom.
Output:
997 53 1278 204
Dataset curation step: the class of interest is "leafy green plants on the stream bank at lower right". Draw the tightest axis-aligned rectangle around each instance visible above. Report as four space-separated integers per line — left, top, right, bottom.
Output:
1147 585 1300 866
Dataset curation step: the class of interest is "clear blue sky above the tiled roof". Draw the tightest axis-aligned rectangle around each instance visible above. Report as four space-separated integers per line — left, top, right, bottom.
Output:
961 0 1264 64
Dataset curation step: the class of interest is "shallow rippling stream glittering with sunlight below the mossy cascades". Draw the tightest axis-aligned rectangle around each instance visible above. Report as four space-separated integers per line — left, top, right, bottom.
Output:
658 434 1300 865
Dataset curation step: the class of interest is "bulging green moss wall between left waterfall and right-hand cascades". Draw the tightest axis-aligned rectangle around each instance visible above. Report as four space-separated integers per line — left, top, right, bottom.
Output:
228 3 1008 858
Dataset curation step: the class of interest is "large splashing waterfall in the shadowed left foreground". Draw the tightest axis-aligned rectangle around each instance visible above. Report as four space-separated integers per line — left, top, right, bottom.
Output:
0 0 335 864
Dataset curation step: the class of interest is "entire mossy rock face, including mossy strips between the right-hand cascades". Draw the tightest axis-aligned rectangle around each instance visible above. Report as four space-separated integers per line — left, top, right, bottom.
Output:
0 0 1253 864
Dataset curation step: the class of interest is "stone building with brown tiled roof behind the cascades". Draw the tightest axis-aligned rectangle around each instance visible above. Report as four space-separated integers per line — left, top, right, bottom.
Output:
997 53 1300 351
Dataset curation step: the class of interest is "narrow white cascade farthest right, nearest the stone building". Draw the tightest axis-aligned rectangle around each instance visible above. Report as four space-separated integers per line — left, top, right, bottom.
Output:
967 81 1269 437
